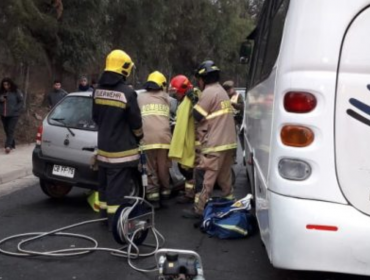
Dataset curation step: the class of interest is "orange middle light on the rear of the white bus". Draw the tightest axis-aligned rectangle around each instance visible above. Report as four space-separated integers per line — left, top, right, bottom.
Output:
280 125 315 148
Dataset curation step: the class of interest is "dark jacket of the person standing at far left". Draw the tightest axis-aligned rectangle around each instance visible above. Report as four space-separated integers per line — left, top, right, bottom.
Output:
0 90 23 117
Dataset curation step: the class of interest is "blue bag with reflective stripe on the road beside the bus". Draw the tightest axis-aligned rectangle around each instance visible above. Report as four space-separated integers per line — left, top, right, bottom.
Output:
201 194 253 239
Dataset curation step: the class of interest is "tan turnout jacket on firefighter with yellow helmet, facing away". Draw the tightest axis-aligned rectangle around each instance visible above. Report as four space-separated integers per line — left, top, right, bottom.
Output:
138 90 171 150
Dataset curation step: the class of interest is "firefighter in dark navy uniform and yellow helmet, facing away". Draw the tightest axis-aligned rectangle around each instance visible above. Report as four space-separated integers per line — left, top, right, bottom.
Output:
92 50 143 230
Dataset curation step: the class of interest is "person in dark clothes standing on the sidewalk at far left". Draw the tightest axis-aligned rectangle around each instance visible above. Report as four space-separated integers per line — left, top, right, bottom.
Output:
0 78 23 154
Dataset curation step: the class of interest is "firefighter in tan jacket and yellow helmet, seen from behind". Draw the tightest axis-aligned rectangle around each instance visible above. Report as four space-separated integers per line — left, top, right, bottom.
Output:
138 71 171 208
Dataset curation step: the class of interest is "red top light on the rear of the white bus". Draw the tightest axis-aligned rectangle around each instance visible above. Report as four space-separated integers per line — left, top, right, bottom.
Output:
284 91 317 113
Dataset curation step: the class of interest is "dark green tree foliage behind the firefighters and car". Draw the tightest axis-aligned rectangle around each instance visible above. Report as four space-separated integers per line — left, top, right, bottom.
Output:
0 0 256 85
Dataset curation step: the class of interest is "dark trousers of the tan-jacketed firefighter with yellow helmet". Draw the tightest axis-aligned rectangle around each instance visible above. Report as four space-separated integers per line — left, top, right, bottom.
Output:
145 149 172 201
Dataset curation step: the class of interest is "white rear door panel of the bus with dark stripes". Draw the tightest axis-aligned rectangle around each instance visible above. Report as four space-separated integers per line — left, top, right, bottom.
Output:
335 8 370 217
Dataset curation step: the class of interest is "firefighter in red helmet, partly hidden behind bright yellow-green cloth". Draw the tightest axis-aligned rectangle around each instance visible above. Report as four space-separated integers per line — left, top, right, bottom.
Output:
170 75 199 204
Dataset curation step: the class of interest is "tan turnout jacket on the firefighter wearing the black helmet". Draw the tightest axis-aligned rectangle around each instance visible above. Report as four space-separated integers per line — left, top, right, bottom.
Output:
194 83 237 154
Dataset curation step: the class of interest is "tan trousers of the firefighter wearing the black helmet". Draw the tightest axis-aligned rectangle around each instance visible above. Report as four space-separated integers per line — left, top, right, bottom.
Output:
194 149 236 214
